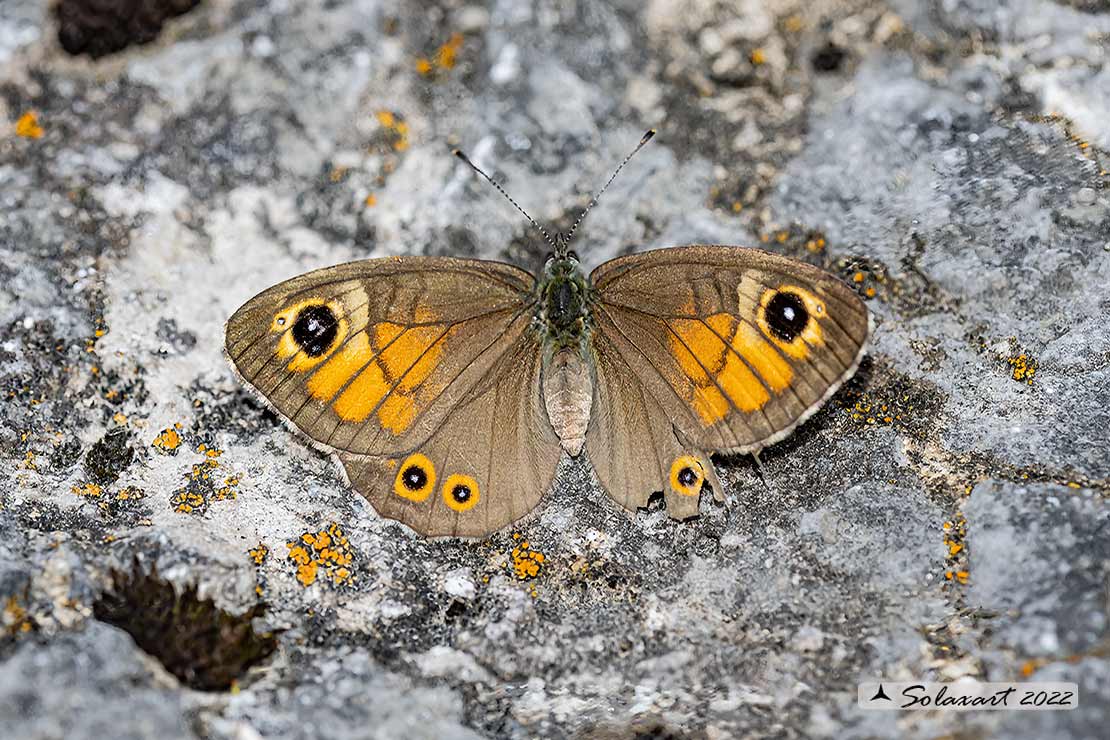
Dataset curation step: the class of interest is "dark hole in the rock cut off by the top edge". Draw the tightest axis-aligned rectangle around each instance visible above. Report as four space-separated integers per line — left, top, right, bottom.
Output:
54 0 200 59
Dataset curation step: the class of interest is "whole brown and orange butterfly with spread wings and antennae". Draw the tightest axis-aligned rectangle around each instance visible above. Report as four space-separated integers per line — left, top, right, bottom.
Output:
225 131 871 537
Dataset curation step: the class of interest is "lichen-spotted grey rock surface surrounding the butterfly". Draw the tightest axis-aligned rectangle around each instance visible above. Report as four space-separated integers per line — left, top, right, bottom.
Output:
0 0 1110 739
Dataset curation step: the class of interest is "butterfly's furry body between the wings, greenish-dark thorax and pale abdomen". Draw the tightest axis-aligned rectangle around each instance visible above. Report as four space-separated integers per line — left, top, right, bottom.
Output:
536 255 594 456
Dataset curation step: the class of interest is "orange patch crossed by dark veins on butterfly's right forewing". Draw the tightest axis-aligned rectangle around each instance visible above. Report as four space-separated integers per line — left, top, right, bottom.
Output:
669 313 794 426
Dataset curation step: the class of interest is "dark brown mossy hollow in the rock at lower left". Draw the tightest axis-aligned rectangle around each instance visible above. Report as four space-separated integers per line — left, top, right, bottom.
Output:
93 562 278 691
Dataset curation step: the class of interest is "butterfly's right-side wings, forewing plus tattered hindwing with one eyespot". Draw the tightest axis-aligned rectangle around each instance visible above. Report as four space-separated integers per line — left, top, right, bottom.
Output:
586 246 870 518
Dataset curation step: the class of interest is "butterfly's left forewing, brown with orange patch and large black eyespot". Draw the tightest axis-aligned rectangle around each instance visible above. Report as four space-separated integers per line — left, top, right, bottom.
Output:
225 257 535 456
